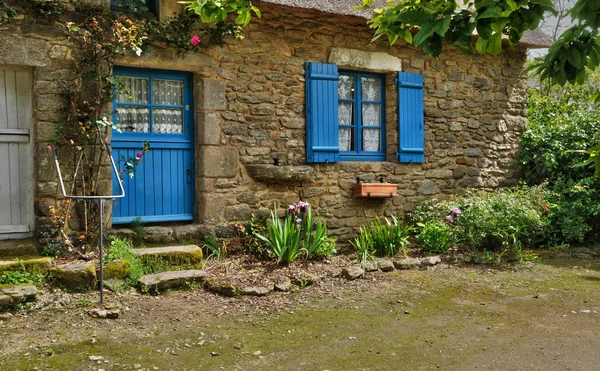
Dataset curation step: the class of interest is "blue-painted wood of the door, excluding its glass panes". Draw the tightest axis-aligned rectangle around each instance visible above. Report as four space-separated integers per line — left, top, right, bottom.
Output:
111 68 194 224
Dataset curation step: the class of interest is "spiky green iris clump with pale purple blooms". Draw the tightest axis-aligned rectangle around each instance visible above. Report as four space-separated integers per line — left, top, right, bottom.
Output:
254 201 336 263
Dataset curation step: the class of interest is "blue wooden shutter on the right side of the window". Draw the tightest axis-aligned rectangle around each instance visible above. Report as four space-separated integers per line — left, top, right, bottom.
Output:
396 72 425 163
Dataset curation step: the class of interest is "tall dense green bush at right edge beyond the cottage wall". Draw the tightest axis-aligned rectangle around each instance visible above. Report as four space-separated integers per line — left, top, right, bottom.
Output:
519 73 600 246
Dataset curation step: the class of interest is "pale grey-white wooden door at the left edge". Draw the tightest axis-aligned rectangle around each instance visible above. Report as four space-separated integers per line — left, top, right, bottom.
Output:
0 66 33 239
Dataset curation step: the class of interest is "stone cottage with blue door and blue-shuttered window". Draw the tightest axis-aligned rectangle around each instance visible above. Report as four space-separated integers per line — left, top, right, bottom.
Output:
0 0 550 240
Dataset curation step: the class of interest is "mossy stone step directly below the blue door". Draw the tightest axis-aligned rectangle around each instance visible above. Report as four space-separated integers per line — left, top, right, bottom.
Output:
134 245 203 268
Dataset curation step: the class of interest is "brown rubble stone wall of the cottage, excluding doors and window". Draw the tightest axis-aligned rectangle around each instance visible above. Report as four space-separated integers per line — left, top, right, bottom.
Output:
0 3 527 244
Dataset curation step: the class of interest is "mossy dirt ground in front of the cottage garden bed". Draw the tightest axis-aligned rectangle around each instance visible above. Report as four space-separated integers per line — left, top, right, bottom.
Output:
0 262 600 371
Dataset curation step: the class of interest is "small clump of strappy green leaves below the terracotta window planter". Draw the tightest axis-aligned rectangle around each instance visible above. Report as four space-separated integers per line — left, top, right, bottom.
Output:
353 217 412 256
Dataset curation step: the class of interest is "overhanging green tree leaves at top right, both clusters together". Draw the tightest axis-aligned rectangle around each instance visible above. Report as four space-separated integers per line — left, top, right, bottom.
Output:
357 0 600 85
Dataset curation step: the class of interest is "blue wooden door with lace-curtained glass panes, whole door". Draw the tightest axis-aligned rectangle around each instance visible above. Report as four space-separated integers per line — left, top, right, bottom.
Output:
111 67 194 224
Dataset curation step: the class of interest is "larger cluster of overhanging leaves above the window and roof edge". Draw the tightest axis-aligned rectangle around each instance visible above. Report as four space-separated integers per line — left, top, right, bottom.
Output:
357 0 554 57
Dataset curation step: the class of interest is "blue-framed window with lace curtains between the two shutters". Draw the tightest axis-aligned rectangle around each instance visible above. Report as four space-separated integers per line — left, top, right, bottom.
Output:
338 71 386 161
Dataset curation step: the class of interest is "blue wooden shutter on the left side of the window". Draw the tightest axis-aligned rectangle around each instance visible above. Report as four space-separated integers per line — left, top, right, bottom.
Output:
306 62 340 162
